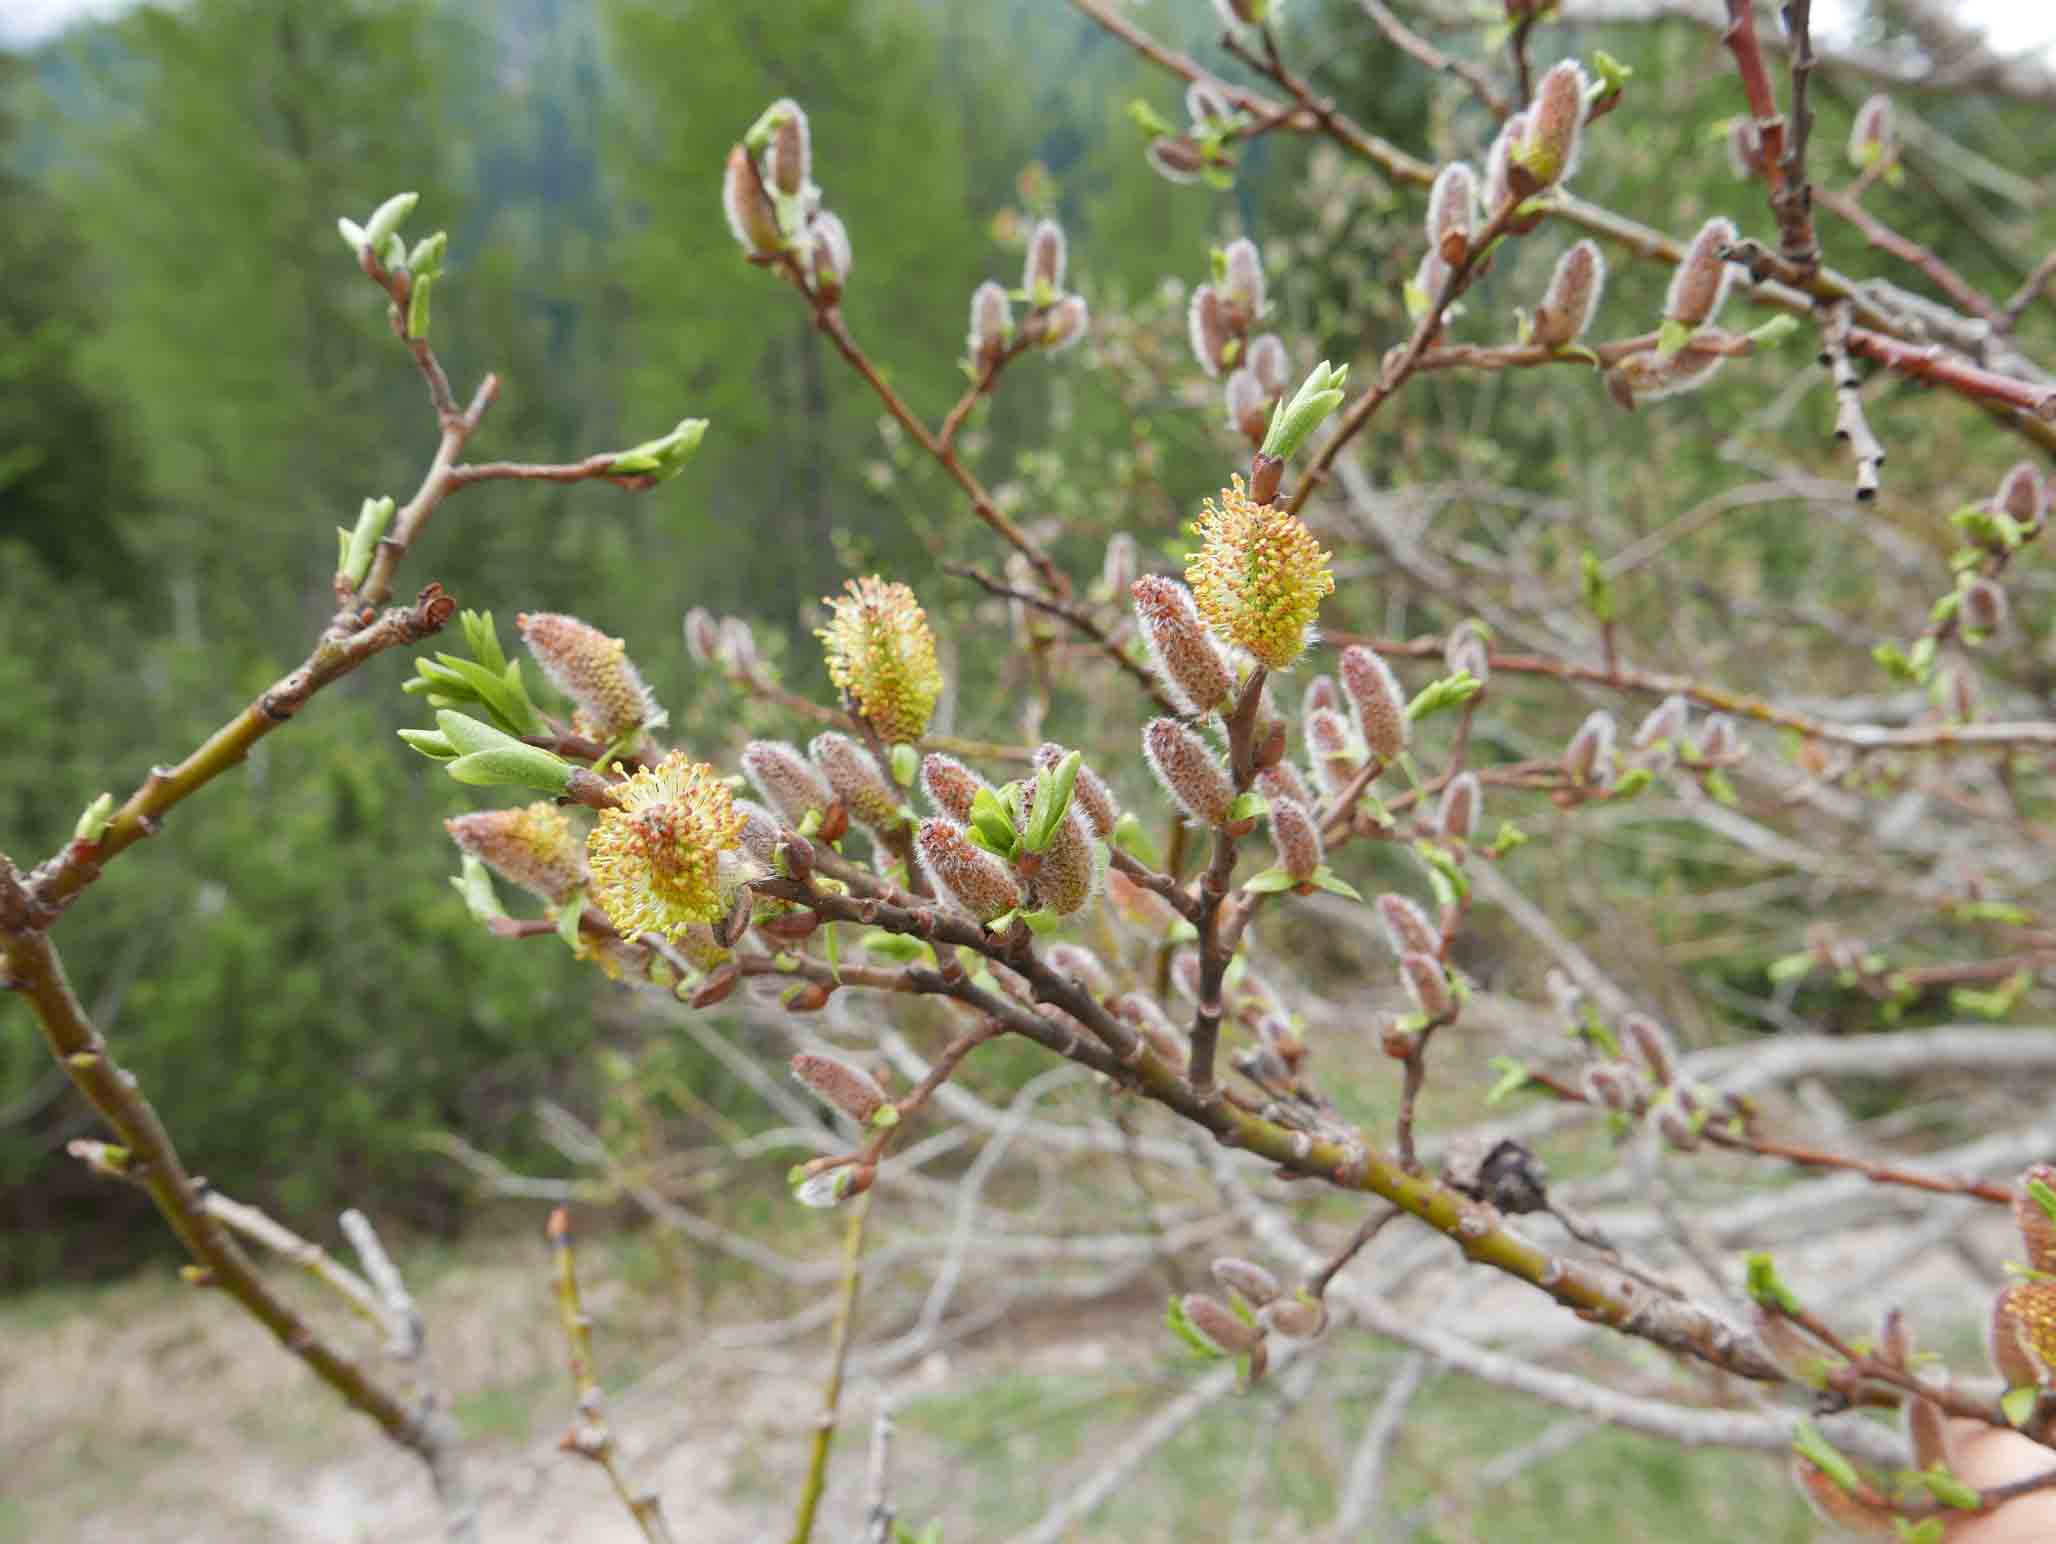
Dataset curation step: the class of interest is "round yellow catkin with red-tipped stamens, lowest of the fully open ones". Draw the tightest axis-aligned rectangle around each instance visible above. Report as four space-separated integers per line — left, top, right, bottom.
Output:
586 750 744 940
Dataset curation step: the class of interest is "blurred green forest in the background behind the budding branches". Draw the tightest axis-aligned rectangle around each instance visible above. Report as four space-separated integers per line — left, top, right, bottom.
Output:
0 0 2056 1285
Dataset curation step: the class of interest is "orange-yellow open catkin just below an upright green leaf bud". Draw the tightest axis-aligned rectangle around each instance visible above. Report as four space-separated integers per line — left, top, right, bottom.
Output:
1184 477 1334 670
